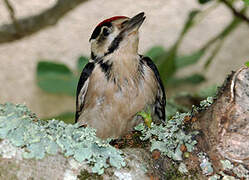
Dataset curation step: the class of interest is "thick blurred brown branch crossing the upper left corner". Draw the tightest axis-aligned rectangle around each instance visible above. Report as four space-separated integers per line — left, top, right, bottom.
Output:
0 0 88 43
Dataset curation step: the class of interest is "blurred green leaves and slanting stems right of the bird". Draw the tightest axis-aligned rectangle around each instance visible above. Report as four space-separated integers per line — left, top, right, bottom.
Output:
145 3 241 86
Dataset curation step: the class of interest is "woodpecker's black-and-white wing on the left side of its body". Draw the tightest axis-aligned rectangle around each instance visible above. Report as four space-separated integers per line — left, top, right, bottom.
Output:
75 62 95 122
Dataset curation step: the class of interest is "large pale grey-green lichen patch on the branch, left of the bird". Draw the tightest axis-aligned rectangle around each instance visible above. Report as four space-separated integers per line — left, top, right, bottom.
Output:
0 103 125 174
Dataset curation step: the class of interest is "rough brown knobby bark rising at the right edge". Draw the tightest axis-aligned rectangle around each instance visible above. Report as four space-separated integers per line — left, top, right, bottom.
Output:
196 67 249 171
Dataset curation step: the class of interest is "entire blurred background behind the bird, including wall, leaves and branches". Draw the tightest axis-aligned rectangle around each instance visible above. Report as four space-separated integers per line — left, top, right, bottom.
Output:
0 0 249 122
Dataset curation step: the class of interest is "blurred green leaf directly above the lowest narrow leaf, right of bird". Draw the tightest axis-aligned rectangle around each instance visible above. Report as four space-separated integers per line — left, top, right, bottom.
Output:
175 49 205 68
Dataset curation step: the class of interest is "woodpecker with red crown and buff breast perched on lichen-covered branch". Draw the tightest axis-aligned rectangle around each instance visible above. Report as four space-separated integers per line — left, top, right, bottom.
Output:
75 12 166 139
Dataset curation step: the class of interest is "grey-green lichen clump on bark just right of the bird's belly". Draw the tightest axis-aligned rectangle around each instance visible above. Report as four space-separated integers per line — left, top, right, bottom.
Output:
135 113 197 160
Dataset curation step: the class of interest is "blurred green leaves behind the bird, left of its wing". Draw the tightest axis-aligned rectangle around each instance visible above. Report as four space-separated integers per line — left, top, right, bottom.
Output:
36 56 88 123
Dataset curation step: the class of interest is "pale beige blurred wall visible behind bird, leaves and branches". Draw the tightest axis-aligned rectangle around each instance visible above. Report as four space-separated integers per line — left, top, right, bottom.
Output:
0 0 249 117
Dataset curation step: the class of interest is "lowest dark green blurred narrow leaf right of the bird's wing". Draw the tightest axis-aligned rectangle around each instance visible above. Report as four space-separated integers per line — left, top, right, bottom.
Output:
168 74 205 86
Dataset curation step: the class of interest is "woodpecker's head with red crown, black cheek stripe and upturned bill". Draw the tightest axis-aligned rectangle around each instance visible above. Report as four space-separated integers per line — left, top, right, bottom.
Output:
90 12 145 59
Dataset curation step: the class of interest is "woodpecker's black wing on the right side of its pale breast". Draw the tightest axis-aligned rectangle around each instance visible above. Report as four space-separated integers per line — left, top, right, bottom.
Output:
142 57 166 121
